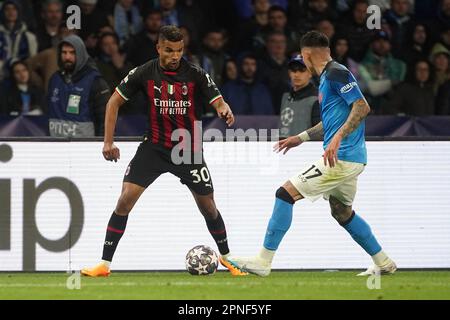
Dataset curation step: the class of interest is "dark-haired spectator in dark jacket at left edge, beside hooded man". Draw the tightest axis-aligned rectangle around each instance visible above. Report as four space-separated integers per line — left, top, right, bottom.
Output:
0 61 45 116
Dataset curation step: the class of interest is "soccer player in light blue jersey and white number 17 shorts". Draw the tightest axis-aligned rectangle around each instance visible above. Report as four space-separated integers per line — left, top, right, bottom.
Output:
230 31 397 276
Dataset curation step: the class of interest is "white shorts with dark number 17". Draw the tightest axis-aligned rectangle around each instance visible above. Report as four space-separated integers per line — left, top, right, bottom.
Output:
289 158 364 206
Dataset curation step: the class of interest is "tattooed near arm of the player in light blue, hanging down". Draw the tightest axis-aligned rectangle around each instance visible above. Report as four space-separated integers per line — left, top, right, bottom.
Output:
323 99 370 168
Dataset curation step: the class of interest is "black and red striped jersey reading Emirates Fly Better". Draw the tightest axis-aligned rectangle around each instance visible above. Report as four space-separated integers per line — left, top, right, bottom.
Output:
116 59 222 150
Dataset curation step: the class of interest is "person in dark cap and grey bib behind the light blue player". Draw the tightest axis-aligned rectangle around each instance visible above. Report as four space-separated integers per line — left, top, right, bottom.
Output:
279 56 320 137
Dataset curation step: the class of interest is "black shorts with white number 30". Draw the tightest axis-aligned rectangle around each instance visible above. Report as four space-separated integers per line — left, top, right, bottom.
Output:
123 140 214 195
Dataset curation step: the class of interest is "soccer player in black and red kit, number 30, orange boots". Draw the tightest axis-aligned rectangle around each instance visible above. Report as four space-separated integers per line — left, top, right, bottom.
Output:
81 26 246 277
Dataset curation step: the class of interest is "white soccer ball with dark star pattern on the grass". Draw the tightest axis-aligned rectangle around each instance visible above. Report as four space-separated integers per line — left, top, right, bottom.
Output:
186 245 219 275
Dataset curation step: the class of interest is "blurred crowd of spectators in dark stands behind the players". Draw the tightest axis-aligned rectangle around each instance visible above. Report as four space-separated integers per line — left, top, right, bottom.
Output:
0 0 450 135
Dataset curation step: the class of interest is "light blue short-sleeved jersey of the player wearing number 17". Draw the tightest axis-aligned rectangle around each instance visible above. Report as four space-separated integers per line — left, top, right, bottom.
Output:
319 61 367 164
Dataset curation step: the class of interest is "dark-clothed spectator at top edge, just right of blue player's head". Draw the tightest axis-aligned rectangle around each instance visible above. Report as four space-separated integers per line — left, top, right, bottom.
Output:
337 0 375 62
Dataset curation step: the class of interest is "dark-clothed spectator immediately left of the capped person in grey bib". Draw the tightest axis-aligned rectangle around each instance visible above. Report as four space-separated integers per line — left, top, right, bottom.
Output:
260 31 290 114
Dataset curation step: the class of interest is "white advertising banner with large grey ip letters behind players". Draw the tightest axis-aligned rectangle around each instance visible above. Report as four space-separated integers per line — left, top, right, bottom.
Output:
0 142 450 271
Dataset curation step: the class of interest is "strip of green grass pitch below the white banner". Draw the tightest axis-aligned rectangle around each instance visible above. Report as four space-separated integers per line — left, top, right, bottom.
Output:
0 271 450 300
